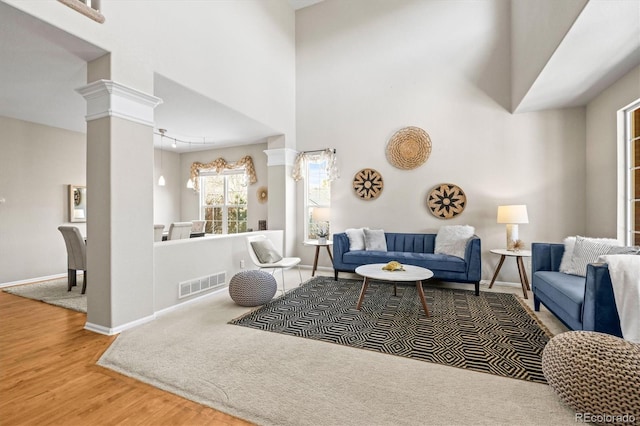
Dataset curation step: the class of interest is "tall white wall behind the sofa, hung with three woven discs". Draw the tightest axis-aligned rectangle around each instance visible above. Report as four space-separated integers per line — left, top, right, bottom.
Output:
296 0 586 282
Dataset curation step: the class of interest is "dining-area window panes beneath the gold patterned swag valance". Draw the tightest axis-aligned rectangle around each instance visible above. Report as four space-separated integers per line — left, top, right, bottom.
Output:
199 169 248 234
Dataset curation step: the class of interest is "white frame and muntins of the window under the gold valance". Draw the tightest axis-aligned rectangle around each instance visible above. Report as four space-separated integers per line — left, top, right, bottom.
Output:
198 167 249 235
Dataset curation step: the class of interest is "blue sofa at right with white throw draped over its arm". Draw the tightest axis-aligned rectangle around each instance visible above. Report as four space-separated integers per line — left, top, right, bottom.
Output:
531 243 622 337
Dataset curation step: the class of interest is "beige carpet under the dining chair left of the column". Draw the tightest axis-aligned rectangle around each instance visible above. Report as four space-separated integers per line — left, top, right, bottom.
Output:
3 275 87 313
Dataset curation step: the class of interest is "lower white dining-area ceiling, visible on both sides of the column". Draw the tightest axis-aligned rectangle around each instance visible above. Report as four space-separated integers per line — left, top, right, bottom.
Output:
0 2 278 152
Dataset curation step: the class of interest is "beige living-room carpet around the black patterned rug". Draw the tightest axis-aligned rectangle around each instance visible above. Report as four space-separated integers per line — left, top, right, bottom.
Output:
99 272 575 425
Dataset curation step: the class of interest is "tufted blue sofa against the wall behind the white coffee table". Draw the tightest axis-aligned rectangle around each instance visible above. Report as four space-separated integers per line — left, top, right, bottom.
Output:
333 232 482 296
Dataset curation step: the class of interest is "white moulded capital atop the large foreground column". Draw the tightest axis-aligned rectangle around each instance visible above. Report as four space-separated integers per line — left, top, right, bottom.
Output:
76 80 162 126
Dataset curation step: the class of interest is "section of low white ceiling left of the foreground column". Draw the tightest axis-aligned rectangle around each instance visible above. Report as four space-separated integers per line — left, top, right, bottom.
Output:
0 2 107 132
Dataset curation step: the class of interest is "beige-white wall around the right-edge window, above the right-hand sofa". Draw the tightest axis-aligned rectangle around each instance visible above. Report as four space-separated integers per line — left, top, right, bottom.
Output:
586 67 640 238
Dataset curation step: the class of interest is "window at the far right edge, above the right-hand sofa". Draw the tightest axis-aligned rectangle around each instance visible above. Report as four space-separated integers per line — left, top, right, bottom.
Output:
625 100 640 245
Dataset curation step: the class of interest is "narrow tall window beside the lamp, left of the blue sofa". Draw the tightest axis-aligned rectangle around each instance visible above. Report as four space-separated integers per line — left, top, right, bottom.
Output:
304 155 331 240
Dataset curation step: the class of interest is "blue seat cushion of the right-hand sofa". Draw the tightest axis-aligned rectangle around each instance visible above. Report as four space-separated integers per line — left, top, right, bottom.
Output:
534 271 585 323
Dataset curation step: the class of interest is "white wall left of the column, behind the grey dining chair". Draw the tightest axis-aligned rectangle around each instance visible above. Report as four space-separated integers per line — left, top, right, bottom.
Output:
0 117 86 284
